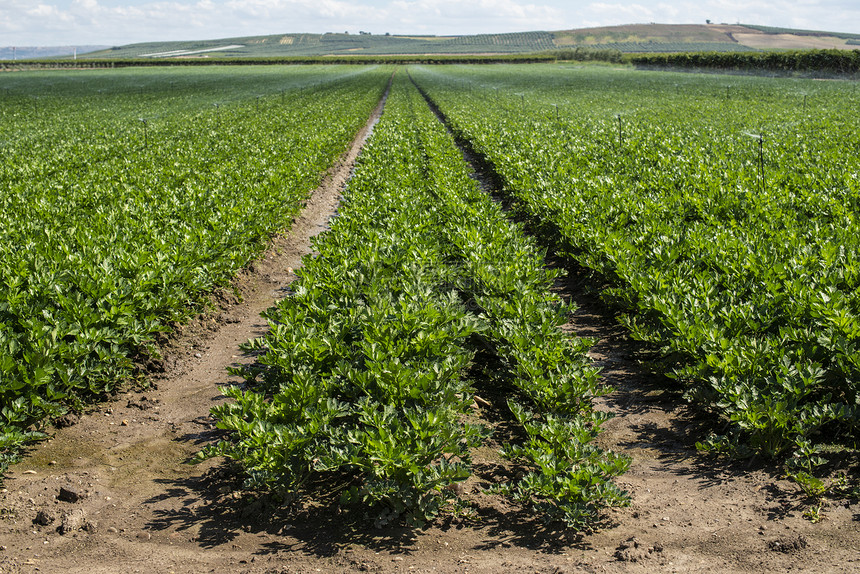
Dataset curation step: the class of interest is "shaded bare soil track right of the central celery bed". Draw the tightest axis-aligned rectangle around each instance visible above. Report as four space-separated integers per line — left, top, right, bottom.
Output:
410 73 860 574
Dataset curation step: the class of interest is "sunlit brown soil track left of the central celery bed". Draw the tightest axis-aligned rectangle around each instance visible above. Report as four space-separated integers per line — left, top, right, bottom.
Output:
0 82 390 574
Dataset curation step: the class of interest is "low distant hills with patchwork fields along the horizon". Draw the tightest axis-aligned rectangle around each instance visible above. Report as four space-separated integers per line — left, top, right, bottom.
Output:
23 24 860 59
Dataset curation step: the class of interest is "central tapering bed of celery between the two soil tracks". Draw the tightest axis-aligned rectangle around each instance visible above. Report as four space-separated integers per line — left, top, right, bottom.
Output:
199 75 628 528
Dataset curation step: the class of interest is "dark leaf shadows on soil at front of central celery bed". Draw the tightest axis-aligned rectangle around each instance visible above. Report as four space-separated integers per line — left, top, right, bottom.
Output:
145 456 613 558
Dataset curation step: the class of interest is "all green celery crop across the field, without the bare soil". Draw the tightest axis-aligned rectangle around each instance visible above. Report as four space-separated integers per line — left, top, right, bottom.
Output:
0 64 860 530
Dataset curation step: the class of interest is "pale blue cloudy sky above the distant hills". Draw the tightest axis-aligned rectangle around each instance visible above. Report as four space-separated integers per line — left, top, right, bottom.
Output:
0 0 860 46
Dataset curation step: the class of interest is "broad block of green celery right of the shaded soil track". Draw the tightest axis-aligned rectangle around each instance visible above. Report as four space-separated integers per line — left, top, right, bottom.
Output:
413 66 860 471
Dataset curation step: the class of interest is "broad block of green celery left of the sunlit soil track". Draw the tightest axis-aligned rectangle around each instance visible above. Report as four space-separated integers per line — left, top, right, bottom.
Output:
0 69 390 467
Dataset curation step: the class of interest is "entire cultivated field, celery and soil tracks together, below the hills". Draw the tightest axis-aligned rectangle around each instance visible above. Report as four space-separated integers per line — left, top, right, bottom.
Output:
0 65 860 573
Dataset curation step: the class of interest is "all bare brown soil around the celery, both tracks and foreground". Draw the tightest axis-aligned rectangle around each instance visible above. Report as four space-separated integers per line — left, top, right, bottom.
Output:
0 88 860 574
